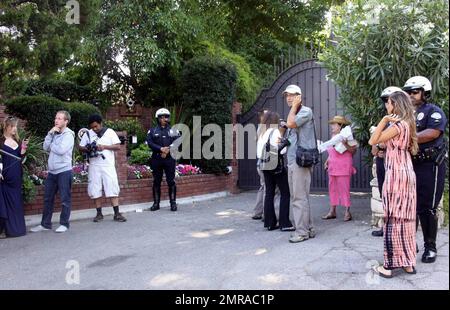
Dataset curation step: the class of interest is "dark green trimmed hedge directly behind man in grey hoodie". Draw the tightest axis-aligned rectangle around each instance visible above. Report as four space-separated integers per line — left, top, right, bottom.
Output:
5 96 100 137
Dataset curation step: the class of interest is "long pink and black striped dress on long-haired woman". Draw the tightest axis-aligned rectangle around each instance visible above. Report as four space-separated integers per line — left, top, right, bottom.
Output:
382 121 416 269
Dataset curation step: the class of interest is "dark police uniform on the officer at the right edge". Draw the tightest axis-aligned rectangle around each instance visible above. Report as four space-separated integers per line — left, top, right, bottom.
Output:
413 103 447 262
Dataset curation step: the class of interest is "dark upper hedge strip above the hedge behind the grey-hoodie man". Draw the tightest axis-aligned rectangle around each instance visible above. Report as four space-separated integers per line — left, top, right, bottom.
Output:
23 80 93 102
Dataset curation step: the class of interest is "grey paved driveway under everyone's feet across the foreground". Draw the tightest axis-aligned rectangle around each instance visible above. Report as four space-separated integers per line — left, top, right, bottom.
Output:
0 192 449 290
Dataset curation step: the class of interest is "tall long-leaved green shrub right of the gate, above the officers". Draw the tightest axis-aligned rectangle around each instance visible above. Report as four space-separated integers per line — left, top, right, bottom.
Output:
320 0 449 146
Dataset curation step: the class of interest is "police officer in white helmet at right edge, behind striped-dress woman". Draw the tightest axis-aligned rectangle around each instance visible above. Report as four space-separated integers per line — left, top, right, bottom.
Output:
403 76 447 263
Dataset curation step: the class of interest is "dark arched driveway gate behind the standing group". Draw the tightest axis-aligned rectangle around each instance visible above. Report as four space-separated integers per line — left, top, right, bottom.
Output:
238 59 371 192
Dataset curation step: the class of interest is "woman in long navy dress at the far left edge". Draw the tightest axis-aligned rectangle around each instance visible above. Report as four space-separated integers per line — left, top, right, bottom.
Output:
0 116 28 237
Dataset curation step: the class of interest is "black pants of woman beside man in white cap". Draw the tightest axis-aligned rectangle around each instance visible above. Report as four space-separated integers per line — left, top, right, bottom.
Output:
264 169 292 228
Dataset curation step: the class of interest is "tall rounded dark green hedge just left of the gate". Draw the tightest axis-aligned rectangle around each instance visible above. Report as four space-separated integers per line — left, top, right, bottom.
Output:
181 57 237 174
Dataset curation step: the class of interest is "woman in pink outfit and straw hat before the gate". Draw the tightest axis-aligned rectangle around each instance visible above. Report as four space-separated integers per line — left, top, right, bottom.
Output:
322 115 356 221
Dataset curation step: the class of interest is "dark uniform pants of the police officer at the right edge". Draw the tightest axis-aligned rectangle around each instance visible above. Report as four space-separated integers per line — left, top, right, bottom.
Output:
414 162 446 252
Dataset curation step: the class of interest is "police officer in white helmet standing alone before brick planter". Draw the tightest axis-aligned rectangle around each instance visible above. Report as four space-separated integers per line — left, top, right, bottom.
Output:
147 109 180 211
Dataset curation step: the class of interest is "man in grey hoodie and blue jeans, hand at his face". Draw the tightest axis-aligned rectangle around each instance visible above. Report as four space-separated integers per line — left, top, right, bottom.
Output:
31 111 75 233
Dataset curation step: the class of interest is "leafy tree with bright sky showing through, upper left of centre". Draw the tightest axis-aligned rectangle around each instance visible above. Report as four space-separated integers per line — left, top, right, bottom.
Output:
85 0 197 105
